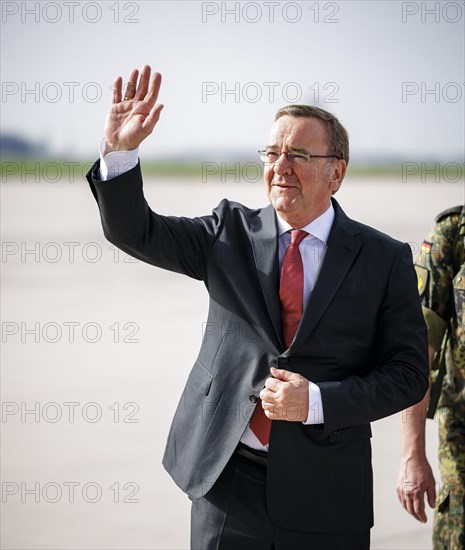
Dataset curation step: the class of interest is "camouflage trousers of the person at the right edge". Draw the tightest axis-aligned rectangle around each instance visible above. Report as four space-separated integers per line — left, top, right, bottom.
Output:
433 404 465 550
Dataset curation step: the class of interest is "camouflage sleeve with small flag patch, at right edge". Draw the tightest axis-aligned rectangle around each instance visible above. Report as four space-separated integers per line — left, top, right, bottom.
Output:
415 215 459 349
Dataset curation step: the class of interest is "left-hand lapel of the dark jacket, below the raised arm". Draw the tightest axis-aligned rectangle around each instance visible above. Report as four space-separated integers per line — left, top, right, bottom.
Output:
250 205 284 347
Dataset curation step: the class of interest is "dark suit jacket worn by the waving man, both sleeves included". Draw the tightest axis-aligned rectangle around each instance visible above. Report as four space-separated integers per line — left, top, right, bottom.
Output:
88 163 428 533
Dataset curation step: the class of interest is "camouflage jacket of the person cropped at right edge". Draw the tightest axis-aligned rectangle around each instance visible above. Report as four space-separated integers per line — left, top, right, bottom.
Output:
415 206 465 407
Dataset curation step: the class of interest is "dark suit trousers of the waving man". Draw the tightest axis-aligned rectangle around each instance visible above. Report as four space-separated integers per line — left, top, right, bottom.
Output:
191 453 370 550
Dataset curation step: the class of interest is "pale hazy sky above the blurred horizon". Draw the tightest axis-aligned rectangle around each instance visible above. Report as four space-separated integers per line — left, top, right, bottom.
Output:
1 0 465 161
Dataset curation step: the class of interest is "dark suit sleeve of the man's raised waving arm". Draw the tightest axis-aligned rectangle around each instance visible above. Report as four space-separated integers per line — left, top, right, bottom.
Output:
86 161 228 281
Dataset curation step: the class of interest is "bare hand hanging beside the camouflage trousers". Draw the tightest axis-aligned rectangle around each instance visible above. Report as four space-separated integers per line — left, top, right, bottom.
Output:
397 457 436 523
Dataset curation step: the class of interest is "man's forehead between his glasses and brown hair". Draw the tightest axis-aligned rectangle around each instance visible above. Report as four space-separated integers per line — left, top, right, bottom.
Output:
268 115 328 149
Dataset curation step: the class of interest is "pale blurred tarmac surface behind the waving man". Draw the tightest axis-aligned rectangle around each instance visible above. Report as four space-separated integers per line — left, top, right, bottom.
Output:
1 177 464 550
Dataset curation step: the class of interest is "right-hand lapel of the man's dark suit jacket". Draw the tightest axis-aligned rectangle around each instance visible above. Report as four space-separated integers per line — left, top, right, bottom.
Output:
290 199 361 349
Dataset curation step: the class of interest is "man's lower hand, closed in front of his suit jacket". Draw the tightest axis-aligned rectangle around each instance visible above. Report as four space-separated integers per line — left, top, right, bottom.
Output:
260 368 309 422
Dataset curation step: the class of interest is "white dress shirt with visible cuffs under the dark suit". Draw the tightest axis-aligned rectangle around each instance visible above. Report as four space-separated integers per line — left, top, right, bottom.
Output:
100 143 328 451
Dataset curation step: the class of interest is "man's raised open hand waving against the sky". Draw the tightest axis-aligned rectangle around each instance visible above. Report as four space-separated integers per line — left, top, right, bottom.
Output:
104 65 163 154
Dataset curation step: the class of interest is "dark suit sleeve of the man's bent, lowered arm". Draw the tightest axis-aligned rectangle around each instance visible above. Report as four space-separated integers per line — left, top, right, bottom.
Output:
318 244 428 431
